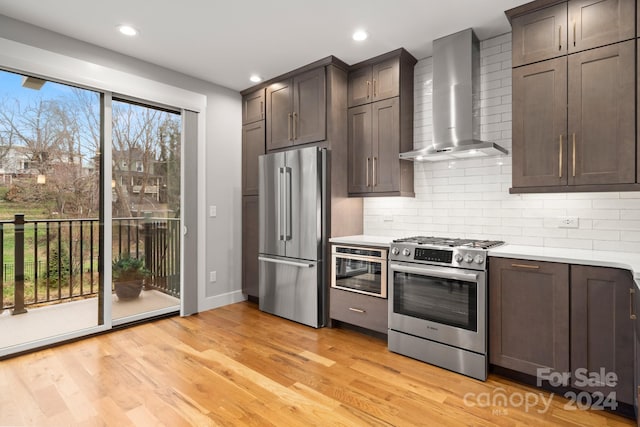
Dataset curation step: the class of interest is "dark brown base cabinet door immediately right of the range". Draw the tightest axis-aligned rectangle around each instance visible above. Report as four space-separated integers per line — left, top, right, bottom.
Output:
489 258 569 376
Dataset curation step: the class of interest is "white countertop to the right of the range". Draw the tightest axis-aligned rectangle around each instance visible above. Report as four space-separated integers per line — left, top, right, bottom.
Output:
489 245 640 287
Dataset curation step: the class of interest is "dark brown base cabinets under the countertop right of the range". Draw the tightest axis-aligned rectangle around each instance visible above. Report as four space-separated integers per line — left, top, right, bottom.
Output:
489 257 640 405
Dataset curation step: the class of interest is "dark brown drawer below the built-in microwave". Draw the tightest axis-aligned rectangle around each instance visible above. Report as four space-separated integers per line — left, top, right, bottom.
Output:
329 288 388 334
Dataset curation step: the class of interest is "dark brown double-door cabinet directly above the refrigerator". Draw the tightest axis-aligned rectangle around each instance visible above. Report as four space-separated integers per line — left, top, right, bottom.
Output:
266 67 327 150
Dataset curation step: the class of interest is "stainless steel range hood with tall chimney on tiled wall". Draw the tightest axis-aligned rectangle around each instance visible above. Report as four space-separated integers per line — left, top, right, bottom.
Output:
400 28 508 161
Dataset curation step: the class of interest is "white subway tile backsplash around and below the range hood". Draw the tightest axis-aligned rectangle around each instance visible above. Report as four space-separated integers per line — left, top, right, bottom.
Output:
364 33 640 252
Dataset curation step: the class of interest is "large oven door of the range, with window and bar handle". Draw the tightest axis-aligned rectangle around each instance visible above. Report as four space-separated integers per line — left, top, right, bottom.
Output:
389 261 487 354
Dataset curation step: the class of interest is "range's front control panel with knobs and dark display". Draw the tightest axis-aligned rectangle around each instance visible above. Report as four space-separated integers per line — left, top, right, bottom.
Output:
389 243 487 270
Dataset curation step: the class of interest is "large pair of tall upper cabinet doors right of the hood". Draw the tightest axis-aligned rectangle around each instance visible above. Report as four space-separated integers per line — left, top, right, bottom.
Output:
512 40 636 190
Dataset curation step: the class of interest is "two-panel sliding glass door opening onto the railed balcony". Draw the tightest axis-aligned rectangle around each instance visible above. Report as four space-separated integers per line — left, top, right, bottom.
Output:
0 70 183 356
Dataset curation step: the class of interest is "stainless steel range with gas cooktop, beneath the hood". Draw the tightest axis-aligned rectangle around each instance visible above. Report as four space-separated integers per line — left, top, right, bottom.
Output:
388 236 503 381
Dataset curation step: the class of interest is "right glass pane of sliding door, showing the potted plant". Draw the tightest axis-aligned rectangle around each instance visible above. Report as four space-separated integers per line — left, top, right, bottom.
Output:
111 100 182 323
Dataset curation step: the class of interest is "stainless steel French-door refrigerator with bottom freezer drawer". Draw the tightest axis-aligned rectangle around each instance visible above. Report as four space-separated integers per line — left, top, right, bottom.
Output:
258 147 327 328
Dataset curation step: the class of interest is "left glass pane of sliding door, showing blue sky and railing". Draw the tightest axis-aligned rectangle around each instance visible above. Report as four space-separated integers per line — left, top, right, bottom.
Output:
0 71 103 353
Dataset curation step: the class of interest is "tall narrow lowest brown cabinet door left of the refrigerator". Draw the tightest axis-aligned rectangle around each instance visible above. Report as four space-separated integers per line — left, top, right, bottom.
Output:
242 196 259 298
